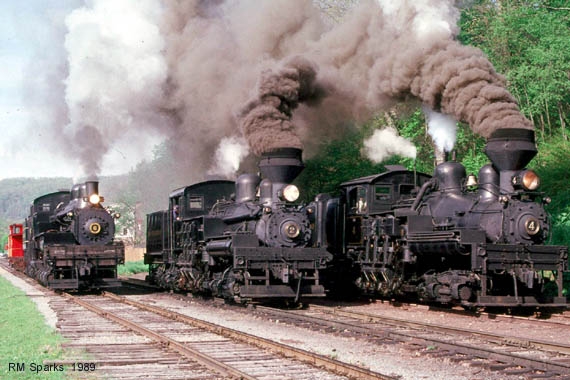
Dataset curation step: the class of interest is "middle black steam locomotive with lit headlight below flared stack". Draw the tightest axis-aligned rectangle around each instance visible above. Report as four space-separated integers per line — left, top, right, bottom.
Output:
145 148 332 302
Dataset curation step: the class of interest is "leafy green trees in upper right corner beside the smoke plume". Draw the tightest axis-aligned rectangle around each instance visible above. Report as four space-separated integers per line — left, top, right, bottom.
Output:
460 0 570 140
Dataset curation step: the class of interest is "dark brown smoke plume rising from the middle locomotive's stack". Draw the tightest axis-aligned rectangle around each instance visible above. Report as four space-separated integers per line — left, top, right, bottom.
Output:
239 57 324 155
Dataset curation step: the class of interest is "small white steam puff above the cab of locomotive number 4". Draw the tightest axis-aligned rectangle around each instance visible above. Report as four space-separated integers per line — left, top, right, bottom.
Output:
364 127 417 162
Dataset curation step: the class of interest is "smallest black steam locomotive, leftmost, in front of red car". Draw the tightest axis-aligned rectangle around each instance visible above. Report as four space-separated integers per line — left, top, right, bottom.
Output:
24 181 125 290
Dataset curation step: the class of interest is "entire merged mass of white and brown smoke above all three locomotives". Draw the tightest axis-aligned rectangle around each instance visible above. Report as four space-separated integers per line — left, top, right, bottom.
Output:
21 0 532 183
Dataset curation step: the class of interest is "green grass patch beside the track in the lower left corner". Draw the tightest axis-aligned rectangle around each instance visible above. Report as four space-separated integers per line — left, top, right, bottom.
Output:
0 277 65 380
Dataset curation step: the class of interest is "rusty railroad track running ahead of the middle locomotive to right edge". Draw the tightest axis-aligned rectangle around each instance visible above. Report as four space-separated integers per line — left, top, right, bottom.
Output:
250 305 570 379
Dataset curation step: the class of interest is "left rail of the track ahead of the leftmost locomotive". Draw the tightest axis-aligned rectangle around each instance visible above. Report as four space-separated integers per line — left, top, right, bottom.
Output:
62 293 255 380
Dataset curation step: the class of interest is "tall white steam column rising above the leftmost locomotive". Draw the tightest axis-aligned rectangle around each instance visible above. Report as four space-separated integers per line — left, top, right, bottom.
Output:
61 0 167 177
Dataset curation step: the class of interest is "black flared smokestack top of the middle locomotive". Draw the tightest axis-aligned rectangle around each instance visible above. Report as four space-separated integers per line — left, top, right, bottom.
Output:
259 148 305 183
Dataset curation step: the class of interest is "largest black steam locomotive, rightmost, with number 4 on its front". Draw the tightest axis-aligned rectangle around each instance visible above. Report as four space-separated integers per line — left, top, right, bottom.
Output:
325 129 568 307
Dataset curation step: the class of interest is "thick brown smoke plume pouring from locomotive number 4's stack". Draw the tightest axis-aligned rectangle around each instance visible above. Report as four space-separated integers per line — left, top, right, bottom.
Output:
373 41 533 137
